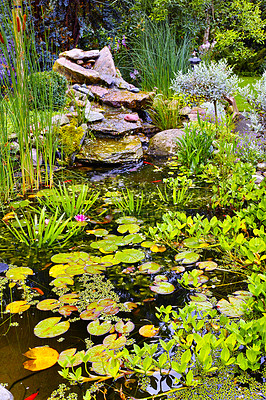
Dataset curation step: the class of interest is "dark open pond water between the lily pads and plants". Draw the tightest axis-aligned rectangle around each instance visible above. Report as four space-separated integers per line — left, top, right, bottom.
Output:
0 162 266 400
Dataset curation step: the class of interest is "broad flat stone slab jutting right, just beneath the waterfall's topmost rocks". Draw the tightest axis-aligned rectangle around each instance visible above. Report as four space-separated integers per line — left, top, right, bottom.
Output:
101 90 154 110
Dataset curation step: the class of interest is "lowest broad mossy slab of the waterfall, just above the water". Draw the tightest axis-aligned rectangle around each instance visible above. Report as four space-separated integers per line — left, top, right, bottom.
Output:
76 136 143 164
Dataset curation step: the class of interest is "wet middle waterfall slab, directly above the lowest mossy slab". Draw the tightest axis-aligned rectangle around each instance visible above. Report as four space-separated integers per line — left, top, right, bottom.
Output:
88 113 142 136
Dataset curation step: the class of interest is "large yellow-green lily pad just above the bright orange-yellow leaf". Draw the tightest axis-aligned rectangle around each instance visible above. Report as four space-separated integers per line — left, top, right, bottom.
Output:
34 317 70 338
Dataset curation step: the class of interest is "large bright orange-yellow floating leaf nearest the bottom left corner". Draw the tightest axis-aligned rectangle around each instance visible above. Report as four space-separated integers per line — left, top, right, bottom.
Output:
23 346 59 371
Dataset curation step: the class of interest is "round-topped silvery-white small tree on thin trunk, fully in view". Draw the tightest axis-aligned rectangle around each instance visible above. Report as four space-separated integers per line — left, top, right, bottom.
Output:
170 60 239 122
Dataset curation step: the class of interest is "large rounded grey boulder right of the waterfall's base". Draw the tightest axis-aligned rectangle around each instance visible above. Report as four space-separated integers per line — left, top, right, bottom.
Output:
147 129 185 157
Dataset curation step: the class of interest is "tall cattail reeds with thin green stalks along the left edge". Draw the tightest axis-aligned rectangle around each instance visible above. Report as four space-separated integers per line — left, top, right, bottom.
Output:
0 1 56 200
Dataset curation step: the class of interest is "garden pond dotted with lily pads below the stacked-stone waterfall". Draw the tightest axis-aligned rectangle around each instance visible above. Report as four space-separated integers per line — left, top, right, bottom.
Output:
0 161 266 400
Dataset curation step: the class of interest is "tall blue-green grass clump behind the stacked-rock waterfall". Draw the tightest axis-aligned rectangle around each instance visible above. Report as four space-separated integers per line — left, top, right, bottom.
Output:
122 19 191 96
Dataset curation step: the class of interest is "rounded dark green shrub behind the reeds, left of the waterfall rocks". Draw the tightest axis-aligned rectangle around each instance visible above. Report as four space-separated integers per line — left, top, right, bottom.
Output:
28 71 67 110
